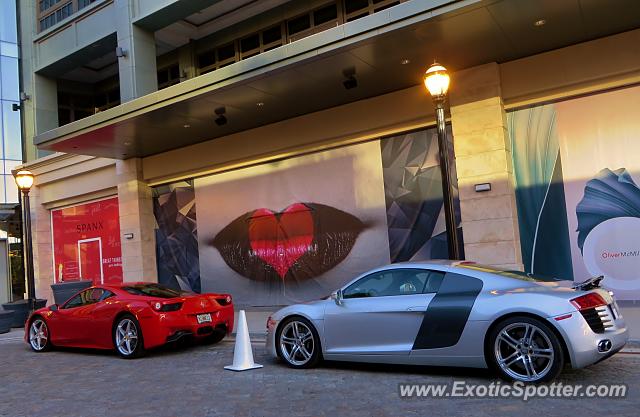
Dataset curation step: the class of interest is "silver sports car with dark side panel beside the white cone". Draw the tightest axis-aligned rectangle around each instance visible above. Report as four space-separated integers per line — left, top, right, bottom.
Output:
267 261 628 382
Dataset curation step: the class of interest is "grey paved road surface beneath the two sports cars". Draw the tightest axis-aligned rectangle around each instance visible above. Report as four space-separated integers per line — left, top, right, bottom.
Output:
0 332 640 417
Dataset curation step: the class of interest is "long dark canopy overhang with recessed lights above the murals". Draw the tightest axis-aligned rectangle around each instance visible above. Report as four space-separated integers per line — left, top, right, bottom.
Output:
35 0 640 159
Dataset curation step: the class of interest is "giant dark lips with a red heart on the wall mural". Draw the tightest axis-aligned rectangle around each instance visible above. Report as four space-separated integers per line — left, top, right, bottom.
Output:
212 203 365 283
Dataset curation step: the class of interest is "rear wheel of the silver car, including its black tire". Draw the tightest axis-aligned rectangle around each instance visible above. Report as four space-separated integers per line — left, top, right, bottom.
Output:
485 316 564 384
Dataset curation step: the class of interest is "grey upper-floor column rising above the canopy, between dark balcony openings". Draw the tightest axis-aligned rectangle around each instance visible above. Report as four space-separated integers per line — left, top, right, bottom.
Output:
114 0 158 103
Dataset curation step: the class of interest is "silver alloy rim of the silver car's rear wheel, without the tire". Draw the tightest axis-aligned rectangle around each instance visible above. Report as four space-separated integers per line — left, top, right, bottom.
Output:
494 323 555 382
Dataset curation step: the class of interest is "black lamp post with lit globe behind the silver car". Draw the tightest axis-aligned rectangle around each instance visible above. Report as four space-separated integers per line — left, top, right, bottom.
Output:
424 62 460 259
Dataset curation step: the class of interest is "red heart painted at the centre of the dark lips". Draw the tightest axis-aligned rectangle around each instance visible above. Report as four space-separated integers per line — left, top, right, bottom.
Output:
249 203 314 278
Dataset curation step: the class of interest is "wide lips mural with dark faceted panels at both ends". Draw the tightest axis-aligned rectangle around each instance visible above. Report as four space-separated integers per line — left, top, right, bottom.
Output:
154 129 458 306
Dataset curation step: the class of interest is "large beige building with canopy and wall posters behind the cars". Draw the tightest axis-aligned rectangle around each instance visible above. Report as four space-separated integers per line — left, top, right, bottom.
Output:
12 0 640 338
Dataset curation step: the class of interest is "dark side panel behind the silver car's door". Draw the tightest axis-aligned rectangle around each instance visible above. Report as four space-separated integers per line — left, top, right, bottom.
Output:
413 273 482 350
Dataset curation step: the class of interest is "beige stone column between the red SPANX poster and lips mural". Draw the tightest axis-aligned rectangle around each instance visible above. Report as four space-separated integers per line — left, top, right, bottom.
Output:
116 158 158 282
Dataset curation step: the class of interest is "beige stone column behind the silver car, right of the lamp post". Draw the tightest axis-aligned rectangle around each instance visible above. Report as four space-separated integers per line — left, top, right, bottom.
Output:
450 63 522 270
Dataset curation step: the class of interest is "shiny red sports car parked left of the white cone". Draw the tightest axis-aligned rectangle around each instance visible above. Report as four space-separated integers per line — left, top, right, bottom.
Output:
25 282 233 358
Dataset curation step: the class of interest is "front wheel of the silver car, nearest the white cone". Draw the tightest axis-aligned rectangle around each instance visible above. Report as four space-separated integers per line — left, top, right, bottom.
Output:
275 316 322 369
